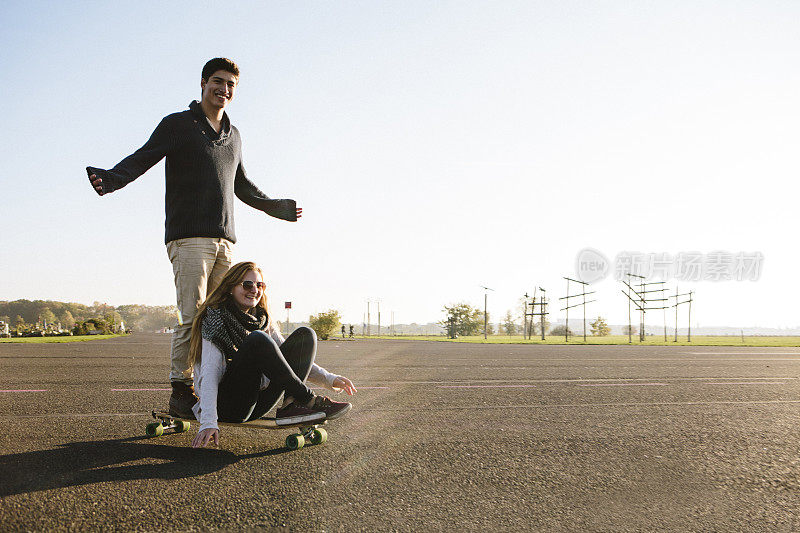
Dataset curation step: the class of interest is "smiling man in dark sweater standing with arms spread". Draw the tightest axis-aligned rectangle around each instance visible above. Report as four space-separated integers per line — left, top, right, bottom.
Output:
86 58 303 418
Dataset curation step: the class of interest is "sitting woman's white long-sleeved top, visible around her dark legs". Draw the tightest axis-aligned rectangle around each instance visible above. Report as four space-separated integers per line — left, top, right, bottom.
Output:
192 328 339 431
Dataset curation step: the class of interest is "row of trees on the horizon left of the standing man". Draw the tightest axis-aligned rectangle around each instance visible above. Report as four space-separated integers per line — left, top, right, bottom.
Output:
0 300 177 335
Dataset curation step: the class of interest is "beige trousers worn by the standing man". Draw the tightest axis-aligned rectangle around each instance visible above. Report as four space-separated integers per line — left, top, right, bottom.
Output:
167 237 233 384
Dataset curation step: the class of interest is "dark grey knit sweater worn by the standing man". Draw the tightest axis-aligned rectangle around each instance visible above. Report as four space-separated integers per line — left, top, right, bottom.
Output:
86 101 297 242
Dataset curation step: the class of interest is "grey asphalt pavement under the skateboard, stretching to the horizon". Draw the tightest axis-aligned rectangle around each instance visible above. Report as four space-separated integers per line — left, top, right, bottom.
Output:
0 334 800 531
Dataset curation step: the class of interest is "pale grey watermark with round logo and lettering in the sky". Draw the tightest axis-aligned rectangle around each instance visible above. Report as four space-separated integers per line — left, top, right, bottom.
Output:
575 248 764 283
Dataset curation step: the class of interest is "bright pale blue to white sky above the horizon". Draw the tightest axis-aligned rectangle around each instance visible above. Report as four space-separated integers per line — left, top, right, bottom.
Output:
0 1 800 326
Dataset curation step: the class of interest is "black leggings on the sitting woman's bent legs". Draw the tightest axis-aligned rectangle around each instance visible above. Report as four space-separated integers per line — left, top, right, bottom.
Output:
217 327 317 422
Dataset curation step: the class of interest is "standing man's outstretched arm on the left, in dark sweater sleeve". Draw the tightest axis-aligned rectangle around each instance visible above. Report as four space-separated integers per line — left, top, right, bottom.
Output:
86 119 175 196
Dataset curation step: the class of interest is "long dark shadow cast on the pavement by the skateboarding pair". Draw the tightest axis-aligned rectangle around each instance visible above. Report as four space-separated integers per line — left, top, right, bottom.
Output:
0 437 288 498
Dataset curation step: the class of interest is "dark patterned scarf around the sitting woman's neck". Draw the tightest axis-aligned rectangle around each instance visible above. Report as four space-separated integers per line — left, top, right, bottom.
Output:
201 300 269 361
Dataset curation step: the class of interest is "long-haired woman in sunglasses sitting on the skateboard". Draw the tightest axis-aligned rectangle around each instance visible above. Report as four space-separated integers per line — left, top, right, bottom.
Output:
189 262 356 448
